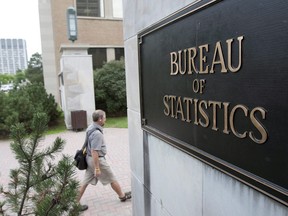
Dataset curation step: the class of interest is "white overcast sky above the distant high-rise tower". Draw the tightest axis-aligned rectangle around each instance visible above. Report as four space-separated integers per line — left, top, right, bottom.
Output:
0 0 42 60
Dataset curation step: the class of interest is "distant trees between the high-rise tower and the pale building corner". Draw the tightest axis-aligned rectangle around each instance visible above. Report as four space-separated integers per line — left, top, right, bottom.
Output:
25 53 44 84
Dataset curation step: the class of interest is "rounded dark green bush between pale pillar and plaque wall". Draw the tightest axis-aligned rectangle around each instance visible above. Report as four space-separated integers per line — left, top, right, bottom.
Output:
94 59 127 116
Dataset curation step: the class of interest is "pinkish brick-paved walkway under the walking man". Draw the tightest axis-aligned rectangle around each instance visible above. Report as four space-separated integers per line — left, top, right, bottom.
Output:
0 128 132 216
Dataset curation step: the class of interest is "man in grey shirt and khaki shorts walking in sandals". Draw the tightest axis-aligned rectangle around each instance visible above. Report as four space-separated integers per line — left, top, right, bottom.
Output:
78 110 131 211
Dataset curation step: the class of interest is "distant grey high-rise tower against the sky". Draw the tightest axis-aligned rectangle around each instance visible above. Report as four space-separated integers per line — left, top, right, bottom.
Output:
0 39 28 74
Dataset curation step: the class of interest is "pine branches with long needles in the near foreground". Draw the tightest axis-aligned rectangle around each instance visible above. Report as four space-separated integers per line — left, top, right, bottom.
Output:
0 113 79 216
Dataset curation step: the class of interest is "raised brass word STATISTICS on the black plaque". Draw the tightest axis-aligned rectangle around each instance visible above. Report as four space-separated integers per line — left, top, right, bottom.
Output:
163 95 268 144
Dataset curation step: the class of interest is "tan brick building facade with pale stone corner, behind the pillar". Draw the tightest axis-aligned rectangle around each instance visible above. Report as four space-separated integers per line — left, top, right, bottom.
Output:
38 0 124 103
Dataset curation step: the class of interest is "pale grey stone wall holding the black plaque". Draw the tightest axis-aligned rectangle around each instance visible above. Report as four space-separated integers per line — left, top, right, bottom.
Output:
124 0 288 216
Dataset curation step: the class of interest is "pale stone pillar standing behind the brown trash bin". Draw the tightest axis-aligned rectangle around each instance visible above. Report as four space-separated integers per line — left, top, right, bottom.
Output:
59 46 95 129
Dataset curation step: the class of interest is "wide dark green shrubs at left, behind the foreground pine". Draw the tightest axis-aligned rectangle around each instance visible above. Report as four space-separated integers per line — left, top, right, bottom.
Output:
0 83 61 136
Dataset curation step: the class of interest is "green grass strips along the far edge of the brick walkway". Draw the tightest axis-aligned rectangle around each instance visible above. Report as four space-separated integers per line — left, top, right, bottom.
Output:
46 116 128 135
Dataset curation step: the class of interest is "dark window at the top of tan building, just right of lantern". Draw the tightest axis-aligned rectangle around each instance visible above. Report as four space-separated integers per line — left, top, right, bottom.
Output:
76 0 104 17
